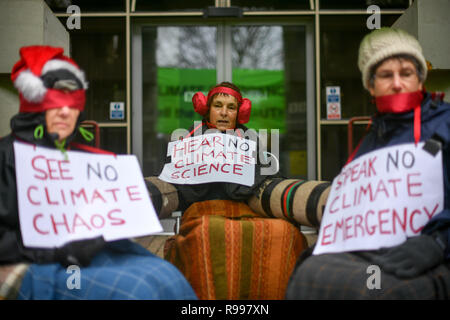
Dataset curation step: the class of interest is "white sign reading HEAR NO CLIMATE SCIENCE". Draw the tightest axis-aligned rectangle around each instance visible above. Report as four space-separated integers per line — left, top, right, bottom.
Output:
159 133 256 186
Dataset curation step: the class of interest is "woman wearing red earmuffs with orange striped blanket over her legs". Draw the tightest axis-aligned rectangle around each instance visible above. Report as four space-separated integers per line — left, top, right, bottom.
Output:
160 82 306 300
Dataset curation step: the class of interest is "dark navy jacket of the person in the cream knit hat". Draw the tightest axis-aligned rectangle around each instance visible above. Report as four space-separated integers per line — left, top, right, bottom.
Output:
355 93 450 259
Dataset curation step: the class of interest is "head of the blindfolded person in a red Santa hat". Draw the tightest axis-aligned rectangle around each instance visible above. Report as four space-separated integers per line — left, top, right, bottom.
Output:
11 46 89 149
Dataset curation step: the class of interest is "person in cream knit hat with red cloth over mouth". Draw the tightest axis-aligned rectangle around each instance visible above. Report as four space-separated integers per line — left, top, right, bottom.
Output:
286 28 450 299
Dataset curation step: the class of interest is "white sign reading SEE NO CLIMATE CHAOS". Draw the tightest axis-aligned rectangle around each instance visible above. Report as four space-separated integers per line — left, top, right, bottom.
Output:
14 142 162 248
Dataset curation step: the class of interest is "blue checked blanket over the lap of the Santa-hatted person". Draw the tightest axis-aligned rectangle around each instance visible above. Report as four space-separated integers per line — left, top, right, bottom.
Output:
0 240 197 300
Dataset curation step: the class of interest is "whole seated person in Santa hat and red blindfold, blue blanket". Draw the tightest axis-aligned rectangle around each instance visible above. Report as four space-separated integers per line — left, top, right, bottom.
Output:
0 46 196 300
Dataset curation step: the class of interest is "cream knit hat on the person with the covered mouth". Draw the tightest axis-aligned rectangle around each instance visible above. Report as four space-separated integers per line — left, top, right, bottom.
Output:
358 28 427 89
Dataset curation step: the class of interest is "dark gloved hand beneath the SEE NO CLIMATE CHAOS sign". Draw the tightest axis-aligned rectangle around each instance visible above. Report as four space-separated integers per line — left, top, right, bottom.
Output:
55 236 105 267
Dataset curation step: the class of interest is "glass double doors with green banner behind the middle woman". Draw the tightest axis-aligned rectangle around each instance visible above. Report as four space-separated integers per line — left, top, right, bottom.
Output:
132 22 316 179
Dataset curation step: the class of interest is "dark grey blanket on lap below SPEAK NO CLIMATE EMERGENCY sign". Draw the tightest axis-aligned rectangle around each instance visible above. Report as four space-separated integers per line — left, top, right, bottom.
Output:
286 249 450 300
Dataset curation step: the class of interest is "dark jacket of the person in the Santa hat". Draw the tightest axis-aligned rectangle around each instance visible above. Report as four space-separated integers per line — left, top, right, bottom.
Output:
0 113 105 265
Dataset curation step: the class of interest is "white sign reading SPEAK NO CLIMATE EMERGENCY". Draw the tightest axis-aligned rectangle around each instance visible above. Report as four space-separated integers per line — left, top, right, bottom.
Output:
313 142 444 254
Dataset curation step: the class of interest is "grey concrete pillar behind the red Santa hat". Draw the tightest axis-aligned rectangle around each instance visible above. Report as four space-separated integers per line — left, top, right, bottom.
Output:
0 0 70 137
